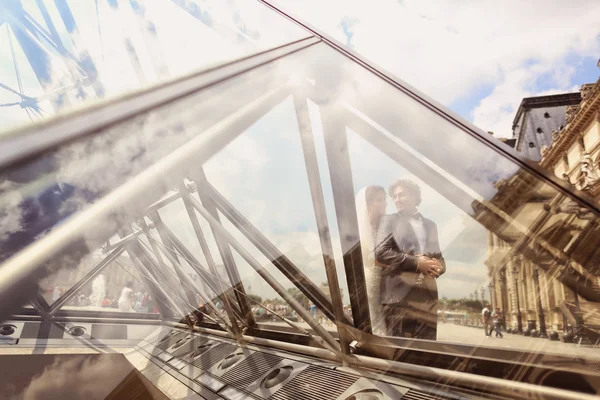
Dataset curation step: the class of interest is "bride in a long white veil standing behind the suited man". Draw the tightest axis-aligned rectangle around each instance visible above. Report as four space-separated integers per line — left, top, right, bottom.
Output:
356 185 387 335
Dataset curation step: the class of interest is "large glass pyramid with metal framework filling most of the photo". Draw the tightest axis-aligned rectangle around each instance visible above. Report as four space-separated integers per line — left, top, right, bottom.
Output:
0 0 600 398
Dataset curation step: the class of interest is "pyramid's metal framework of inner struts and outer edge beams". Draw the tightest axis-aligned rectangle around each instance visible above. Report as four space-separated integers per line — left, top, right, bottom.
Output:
0 0 599 378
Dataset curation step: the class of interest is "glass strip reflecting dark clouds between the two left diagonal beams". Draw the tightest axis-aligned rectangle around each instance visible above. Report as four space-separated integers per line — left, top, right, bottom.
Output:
0 54 285 260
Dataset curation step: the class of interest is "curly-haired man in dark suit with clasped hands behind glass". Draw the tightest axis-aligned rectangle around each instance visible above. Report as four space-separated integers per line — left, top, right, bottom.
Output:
375 180 446 340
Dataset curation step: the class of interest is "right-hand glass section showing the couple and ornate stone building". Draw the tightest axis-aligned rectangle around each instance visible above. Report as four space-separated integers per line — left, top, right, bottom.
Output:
292 46 600 353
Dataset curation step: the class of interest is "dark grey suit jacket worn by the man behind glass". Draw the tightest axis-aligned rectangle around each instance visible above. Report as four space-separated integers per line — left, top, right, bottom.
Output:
375 213 446 304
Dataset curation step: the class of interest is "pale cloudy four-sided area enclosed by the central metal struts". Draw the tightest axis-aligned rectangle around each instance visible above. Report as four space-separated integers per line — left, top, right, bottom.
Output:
206 98 316 237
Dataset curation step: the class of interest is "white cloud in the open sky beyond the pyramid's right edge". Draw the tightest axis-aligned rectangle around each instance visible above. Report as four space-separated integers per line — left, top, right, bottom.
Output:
276 0 600 136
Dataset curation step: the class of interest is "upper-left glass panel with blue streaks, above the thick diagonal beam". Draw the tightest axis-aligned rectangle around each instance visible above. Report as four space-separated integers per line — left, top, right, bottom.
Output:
0 0 310 129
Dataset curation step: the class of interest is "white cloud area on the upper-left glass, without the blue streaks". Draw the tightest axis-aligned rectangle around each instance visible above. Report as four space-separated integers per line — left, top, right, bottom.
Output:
0 0 308 131
